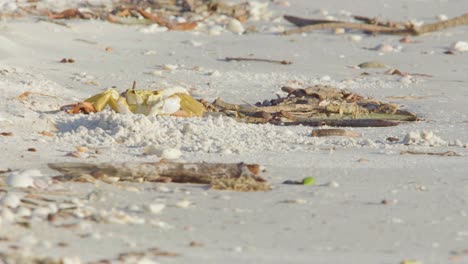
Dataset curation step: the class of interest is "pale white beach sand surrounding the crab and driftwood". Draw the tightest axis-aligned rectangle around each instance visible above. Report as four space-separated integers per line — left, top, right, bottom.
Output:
0 0 468 263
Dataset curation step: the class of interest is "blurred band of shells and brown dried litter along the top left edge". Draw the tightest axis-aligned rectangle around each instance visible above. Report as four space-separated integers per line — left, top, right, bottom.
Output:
12 0 272 34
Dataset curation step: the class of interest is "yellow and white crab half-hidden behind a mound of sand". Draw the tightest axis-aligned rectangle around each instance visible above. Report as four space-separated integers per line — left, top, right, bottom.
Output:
63 84 205 117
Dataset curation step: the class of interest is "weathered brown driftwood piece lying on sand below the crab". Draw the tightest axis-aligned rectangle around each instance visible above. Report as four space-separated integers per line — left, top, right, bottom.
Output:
49 161 270 191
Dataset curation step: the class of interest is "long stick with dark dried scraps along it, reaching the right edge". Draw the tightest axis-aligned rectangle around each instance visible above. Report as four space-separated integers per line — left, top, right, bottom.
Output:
282 13 468 36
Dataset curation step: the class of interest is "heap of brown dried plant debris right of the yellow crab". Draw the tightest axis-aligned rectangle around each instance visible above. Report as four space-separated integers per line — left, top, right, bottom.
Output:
207 85 418 127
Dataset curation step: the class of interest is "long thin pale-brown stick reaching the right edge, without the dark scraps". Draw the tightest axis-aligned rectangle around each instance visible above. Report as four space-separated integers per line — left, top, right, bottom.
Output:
282 13 468 35
